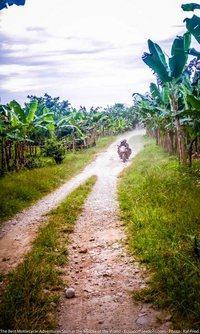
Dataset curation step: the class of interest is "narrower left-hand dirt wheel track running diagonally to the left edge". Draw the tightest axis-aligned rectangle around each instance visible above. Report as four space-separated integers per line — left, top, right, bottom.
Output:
0 130 142 273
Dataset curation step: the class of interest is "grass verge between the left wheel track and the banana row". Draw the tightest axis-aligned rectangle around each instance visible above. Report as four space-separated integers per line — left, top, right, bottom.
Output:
0 137 114 222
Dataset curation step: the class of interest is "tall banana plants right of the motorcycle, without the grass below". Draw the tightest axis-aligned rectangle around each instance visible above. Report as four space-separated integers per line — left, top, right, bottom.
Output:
133 3 200 165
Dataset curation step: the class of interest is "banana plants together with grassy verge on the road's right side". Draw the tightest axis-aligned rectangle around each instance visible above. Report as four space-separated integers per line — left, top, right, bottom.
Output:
119 3 200 329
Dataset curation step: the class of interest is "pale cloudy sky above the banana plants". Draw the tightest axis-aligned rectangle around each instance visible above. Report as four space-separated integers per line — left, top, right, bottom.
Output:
0 0 198 107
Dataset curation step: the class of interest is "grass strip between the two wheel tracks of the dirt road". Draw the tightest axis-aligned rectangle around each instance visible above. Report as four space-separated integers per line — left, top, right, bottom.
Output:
0 177 96 330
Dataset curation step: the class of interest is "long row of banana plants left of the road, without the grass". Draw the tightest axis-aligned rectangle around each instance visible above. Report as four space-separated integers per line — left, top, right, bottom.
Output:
0 94 137 175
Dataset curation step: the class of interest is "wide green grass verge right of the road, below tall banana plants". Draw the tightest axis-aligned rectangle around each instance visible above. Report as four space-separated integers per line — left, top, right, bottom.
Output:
119 138 200 328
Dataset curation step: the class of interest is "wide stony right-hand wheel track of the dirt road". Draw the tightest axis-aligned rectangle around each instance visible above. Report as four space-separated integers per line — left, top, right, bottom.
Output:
58 132 170 333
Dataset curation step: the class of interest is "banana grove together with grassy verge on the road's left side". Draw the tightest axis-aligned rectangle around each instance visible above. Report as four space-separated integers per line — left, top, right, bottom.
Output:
0 94 137 222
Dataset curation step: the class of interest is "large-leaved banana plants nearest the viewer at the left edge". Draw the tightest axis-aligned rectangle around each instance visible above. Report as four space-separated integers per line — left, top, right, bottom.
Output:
0 100 54 169
